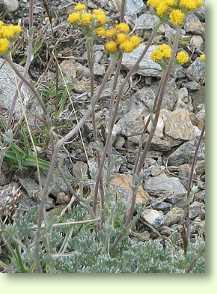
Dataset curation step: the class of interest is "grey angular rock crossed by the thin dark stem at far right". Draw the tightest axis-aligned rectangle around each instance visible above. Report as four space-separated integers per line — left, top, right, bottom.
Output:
168 139 205 166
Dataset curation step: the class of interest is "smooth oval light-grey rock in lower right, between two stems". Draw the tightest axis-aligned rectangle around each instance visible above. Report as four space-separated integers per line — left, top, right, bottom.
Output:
144 175 186 198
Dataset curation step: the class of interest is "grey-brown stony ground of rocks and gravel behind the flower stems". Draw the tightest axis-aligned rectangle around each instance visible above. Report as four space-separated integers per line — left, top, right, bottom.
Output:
0 0 207 250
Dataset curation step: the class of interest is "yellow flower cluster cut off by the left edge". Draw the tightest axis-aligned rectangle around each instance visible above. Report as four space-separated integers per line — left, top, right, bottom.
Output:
0 21 22 55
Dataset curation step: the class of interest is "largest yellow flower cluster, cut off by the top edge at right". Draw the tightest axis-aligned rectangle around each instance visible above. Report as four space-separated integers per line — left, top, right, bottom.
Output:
147 0 203 26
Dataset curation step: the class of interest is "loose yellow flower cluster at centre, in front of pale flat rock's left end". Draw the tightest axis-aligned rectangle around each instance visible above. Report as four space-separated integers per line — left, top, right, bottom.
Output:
99 22 142 53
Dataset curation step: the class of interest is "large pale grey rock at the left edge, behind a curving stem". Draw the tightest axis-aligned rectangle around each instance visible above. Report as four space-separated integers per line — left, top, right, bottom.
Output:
0 58 31 119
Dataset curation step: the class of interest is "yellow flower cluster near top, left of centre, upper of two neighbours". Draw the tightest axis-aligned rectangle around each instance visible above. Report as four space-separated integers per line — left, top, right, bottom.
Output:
68 3 108 27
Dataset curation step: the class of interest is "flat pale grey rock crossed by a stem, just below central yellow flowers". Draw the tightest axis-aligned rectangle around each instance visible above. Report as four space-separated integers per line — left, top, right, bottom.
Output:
122 43 161 77
